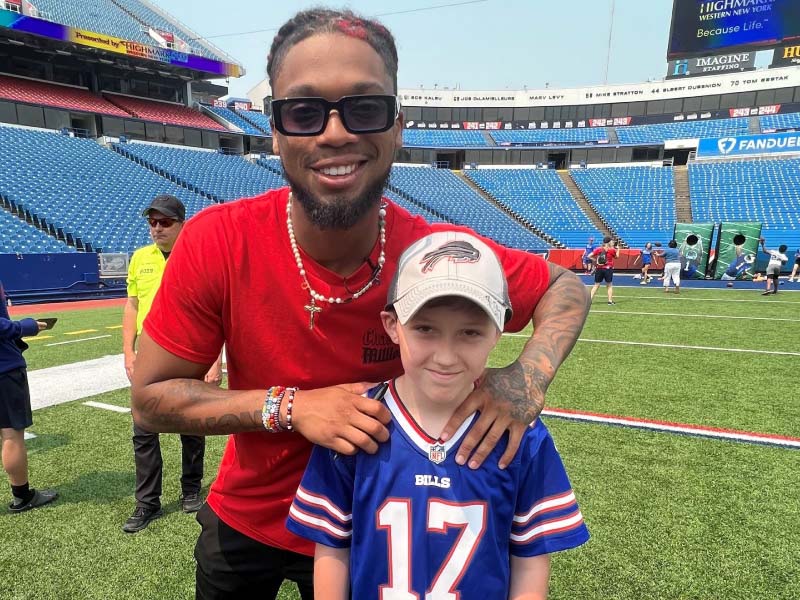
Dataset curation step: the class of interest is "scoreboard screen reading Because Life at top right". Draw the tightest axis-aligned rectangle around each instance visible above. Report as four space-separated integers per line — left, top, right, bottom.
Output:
667 0 800 60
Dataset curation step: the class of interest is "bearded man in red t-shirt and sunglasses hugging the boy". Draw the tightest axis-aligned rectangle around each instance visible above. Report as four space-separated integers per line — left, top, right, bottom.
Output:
132 9 588 599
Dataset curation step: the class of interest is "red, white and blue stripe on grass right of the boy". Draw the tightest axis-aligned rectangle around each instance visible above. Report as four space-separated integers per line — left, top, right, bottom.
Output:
542 408 800 450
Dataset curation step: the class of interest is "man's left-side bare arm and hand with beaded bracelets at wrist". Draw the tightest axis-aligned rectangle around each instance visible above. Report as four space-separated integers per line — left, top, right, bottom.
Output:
131 331 390 454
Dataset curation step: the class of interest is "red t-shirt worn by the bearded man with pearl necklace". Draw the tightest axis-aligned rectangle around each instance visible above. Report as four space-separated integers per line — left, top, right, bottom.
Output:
144 188 549 555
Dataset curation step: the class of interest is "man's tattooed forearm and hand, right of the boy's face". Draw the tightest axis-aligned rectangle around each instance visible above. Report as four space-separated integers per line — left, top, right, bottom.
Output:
442 263 589 468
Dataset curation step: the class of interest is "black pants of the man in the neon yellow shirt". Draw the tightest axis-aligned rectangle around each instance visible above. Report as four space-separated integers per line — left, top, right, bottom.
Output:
133 423 206 508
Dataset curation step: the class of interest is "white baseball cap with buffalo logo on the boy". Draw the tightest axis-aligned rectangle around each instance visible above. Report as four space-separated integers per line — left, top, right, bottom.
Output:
386 231 511 331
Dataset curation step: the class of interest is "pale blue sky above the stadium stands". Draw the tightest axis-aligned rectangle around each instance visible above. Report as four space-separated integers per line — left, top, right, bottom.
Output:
151 0 768 96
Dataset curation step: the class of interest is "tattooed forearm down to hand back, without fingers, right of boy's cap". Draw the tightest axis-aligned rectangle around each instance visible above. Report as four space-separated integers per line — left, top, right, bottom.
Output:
504 263 590 423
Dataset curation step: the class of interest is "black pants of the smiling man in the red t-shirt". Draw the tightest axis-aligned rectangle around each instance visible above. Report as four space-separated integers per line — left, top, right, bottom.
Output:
194 504 314 600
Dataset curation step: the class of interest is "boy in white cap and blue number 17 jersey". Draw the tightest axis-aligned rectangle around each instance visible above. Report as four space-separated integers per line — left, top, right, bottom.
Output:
287 232 589 600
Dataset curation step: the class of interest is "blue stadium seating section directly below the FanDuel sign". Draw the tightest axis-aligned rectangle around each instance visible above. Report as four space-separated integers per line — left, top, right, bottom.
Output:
689 158 800 249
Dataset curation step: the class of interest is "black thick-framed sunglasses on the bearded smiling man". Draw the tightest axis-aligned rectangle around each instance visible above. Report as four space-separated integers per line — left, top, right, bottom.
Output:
272 94 400 136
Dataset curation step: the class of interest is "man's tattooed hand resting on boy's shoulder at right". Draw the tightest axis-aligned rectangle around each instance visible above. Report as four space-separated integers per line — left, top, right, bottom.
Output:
442 360 544 469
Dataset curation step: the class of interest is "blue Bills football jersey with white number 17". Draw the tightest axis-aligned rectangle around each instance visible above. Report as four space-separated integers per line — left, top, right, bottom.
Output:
287 382 589 600
